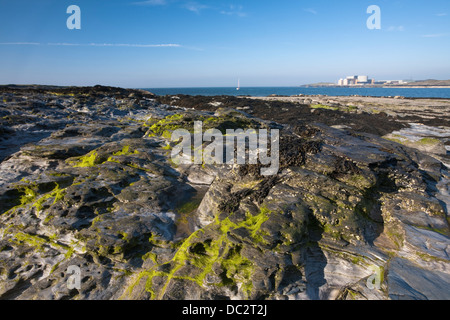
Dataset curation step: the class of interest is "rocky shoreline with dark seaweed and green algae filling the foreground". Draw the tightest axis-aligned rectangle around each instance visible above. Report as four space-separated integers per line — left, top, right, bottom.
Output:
0 86 450 300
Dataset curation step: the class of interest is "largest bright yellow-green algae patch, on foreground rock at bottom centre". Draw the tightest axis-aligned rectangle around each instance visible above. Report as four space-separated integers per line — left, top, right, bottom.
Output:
128 207 271 299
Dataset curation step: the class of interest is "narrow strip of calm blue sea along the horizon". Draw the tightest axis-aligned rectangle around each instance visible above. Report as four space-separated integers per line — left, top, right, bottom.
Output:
144 87 450 99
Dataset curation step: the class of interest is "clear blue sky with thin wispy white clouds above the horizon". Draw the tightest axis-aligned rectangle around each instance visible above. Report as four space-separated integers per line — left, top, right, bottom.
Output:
0 0 450 88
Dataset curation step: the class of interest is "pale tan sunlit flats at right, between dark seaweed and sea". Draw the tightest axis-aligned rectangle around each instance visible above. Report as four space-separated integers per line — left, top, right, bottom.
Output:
243 96 450 168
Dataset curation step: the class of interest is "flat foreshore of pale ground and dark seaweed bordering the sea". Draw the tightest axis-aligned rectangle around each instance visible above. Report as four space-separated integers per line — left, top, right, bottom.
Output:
156 95 450 165
